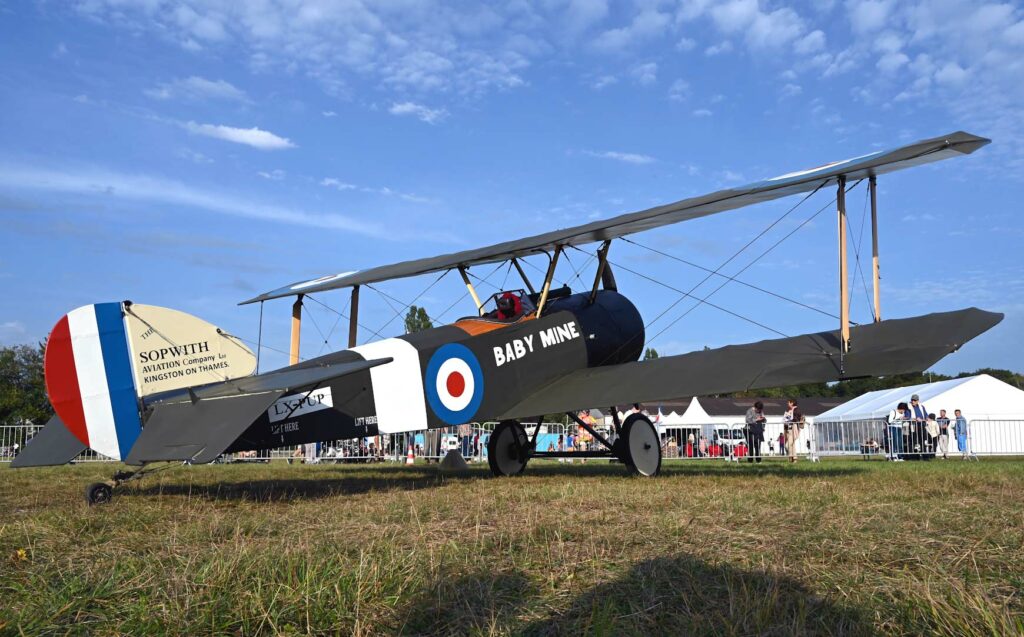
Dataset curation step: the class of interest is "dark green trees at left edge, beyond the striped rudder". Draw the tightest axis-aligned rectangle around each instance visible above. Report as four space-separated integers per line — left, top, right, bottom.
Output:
0 343 53 425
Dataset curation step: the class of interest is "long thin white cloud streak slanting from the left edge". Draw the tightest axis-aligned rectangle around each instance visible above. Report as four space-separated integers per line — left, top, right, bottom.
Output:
0 165 397 239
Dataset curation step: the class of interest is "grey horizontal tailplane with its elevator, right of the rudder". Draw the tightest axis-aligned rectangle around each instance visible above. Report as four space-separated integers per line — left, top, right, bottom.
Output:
125 358 392 465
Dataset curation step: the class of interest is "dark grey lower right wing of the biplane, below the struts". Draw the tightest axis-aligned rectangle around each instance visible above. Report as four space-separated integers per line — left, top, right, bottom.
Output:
499 307 1002 419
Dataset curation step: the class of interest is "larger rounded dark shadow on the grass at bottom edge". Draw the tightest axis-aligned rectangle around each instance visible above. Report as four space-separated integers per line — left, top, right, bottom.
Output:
516 555 877 635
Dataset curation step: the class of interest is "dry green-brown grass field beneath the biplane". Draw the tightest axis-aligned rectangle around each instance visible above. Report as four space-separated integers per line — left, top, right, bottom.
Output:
0 460 1024 635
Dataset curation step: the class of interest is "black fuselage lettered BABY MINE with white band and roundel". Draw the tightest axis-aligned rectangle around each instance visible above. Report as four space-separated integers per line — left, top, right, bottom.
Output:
227 290 644 452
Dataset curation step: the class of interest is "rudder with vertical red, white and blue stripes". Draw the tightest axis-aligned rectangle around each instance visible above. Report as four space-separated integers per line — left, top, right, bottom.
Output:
43 303 142 460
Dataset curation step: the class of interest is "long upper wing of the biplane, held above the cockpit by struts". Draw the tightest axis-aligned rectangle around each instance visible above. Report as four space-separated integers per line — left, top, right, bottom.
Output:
242 132 991 305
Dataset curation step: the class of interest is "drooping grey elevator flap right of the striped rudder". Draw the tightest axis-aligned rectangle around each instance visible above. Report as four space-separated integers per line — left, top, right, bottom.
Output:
125 389 285 465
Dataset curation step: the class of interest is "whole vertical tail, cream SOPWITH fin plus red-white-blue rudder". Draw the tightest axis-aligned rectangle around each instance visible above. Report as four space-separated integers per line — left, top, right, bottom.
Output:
44 301 256 460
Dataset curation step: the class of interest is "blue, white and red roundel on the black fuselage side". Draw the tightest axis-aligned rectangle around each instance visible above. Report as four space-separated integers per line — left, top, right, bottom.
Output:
423 343 483 425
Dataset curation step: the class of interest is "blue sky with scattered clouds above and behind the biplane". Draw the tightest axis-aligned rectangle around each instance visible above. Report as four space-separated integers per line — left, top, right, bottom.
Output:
0 0 1024 373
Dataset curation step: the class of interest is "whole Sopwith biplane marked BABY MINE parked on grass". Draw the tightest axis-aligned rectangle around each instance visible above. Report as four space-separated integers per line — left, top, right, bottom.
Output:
13 132 1002 503
